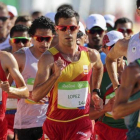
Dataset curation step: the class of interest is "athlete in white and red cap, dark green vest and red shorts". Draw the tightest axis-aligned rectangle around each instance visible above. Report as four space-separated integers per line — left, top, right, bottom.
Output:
89 31 127 140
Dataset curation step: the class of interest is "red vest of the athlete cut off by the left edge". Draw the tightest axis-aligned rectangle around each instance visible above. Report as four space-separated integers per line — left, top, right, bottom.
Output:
0 63 7 119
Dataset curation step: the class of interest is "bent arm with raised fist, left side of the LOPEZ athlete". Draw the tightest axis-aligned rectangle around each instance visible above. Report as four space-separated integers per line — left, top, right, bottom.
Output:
32 52 64 102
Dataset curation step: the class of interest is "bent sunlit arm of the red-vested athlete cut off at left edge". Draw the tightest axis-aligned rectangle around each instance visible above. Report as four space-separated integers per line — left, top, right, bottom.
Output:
1 53 29 98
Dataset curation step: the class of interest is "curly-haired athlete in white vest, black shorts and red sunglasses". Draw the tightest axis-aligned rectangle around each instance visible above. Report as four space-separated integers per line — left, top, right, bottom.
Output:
14 16 55 140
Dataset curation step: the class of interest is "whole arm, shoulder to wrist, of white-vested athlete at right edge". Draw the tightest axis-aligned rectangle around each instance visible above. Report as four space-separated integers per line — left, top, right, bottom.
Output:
106 39 128 88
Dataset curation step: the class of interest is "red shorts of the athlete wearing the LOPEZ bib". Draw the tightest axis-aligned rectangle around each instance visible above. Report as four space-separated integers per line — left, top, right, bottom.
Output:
43 117 92 140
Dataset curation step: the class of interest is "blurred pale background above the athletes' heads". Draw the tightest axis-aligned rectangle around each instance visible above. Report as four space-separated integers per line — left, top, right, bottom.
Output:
0 0 140 33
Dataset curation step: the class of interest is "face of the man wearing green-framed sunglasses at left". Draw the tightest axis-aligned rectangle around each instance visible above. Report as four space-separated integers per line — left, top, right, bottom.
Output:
10 32 31 52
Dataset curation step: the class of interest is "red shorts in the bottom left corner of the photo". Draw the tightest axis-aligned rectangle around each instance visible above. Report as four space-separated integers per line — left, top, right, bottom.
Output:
0 118 7 140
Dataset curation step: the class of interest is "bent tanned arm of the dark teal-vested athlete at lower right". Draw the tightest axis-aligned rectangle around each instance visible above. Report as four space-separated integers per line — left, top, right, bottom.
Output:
113 63 140 119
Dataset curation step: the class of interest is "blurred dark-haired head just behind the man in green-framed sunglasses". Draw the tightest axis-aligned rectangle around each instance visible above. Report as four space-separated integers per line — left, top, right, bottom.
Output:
15 15 32 27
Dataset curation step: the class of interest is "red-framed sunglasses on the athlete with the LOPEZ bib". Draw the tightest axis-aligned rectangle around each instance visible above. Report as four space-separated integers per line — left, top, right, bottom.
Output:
56 25 78 32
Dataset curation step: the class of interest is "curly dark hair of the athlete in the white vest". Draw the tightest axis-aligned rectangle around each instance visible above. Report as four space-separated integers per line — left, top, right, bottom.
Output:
29 16 55 36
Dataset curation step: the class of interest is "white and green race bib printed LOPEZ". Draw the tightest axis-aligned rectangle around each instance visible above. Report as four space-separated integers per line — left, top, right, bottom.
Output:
57 81 88 109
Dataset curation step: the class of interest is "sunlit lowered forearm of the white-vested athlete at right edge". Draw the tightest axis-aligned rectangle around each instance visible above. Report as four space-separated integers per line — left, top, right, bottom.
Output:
106 57 119 88
